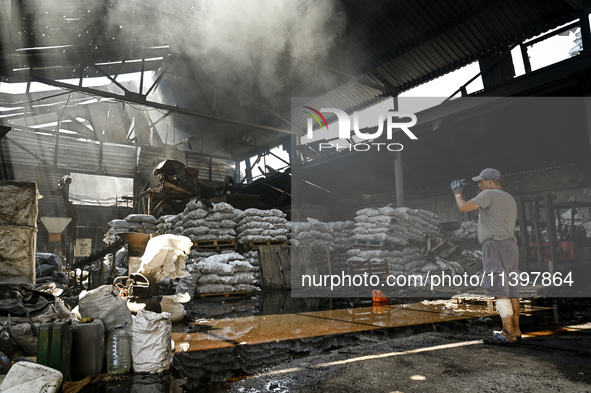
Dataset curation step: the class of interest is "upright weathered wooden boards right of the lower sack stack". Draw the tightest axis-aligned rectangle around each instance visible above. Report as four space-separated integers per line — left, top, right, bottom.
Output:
259 245 291 289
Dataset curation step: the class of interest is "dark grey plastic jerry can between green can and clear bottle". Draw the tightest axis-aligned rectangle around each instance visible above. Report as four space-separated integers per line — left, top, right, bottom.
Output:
70 319 105 381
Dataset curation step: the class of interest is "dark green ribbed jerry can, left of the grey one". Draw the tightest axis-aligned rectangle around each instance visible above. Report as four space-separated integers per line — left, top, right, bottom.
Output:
37 321 72 381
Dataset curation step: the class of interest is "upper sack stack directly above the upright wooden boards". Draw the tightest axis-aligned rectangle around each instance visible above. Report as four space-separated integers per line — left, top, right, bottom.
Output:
236 208 289 244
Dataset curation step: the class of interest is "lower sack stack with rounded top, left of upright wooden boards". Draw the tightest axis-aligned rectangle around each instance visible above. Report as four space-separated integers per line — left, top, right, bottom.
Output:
196 251 257 294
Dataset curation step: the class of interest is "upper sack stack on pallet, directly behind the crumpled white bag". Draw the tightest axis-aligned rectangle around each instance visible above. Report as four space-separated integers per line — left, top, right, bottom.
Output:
168 201 236 242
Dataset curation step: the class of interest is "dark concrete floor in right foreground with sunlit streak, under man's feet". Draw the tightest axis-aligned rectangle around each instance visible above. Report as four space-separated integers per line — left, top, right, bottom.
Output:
222 323 591 393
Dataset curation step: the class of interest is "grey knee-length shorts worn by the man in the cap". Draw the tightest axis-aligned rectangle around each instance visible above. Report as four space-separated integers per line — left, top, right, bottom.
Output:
482 239 519 298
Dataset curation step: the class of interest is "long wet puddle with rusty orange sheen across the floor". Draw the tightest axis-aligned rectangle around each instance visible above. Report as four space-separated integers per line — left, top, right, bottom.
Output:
81 292 588 393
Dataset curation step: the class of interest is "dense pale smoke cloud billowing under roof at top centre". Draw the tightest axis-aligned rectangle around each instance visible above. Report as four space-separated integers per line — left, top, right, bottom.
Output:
109 0 345 96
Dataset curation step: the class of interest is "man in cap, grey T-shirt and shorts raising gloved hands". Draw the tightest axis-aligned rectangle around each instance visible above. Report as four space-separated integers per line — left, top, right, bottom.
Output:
451 168 521 344
